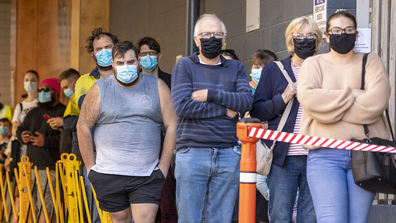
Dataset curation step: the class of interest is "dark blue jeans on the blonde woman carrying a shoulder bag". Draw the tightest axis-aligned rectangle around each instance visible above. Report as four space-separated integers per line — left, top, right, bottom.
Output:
267 155 316 223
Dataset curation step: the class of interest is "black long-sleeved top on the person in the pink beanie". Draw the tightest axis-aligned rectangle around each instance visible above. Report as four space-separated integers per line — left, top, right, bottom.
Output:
17 103 66 169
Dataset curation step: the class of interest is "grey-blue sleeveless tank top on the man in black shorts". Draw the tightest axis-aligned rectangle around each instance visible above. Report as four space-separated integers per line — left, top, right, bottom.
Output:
93 73 163 176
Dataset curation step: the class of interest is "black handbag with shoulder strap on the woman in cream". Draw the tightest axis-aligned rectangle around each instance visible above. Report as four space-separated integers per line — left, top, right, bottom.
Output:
351 54 396 194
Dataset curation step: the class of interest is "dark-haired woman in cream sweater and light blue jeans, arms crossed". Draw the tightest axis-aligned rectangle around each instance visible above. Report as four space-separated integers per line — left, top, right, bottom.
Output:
297 10 390 223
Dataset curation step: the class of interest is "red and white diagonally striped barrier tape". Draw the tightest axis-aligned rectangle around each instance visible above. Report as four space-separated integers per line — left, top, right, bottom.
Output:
248 128 396 153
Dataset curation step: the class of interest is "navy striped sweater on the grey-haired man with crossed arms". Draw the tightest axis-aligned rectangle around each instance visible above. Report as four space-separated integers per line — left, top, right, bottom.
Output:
172 53 253 149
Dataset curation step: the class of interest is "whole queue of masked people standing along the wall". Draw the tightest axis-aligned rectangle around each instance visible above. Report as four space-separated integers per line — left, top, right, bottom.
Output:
0 10 390 223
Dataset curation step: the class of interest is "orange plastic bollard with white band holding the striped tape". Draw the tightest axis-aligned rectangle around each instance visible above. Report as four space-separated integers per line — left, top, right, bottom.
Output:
237 118 262 223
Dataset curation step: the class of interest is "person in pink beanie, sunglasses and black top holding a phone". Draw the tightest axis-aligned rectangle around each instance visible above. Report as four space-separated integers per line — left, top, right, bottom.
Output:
17 78 66 222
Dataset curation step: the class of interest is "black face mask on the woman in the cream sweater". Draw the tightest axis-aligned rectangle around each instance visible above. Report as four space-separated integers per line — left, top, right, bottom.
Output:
329 33 356 54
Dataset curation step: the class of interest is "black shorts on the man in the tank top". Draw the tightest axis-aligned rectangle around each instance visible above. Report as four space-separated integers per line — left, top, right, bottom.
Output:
88 169 165 212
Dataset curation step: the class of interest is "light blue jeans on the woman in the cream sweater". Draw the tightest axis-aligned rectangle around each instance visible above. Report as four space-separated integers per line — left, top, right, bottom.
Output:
307 148 375 223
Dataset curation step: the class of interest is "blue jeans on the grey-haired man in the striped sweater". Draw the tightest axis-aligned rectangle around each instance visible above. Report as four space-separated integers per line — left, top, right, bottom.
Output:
175 146 241 223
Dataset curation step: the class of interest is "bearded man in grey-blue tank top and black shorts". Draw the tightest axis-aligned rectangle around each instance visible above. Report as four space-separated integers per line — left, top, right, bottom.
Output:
77 41 177 223
